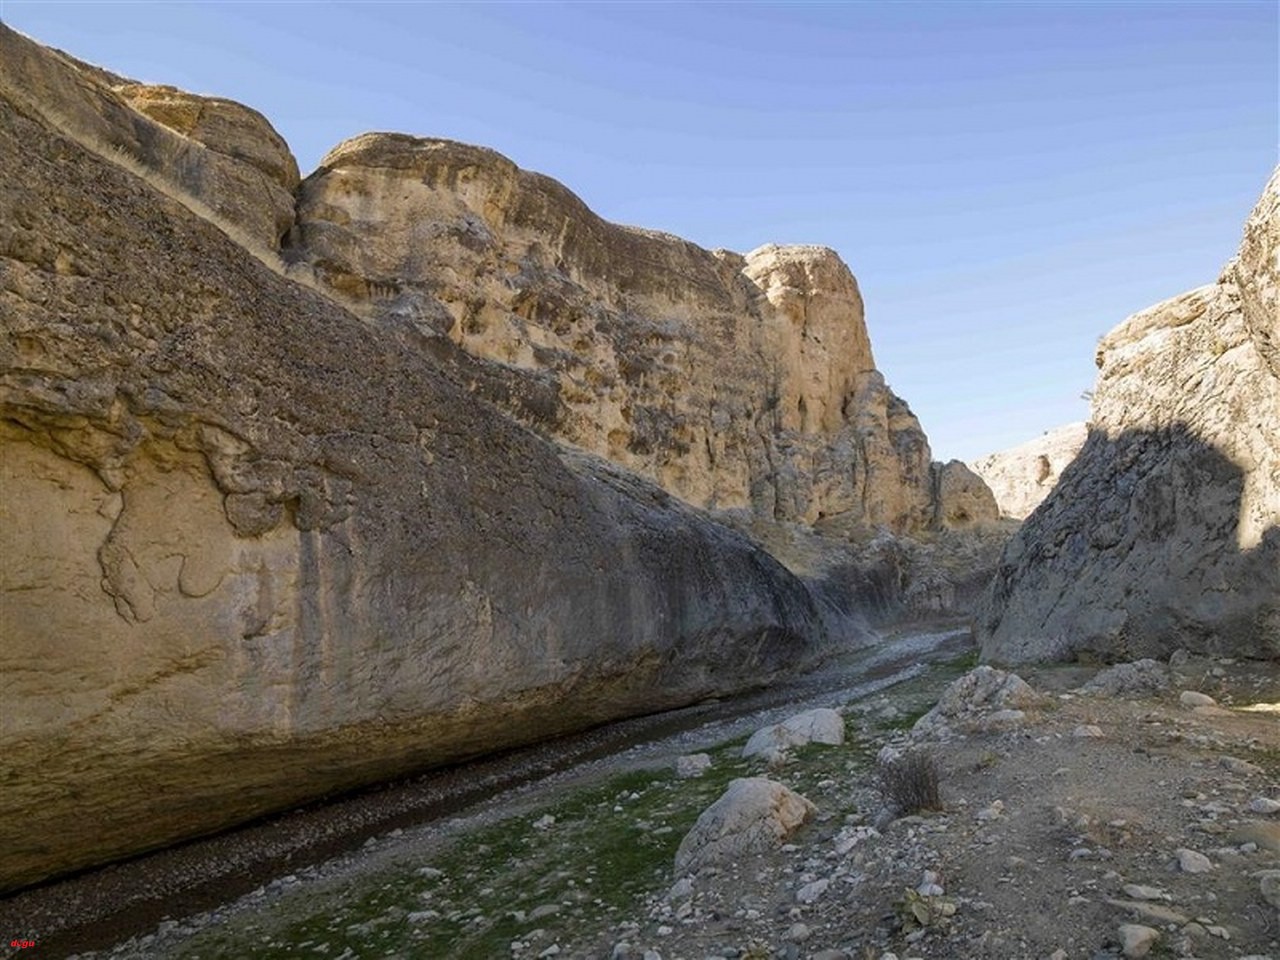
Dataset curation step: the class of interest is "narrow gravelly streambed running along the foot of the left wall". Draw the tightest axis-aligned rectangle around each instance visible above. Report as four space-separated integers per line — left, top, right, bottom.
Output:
0 628 972 957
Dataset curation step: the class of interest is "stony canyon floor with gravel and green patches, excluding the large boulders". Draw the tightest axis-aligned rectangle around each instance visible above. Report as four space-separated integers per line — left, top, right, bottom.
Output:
10 639 1280 960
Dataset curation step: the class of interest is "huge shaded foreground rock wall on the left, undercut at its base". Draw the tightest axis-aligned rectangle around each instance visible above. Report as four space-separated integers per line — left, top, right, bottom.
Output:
0 28 870 890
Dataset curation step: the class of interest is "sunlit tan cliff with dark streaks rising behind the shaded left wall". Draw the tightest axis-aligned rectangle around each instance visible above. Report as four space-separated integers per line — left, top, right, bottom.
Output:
287 133 982 534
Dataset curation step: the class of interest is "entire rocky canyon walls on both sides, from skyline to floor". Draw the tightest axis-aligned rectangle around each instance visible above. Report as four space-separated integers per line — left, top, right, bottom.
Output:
0 18 1280 921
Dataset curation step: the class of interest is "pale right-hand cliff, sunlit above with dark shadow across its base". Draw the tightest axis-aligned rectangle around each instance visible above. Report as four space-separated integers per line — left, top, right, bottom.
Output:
977 173 1280 660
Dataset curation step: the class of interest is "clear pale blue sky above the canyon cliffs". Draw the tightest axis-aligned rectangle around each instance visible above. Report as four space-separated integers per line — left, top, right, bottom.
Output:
0 0 1280 460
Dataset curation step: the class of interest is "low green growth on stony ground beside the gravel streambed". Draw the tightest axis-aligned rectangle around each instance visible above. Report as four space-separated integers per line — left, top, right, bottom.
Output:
172 721 868 960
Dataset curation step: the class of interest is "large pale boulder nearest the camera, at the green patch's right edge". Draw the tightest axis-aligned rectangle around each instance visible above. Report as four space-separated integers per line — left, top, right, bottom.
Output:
676 777 818 873
